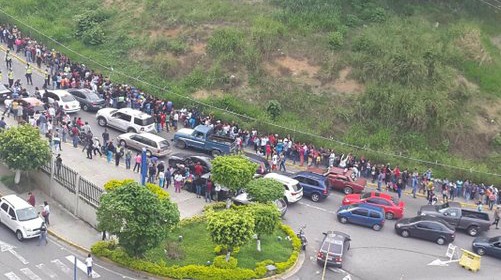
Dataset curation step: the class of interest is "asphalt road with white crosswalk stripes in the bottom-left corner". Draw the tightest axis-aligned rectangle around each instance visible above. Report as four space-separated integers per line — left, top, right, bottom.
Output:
0 222 138 280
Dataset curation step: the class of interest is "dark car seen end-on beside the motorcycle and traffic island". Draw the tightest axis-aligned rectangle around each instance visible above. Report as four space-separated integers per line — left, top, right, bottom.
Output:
317 231 351 268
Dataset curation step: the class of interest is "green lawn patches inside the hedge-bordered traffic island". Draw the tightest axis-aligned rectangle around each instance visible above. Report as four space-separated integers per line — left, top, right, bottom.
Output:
145 222 292 269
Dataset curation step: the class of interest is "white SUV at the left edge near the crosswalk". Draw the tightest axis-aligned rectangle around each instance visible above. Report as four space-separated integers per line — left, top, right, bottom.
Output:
0 194 43 241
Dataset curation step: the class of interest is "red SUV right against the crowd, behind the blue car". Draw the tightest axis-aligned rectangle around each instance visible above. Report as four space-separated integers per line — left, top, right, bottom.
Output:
308 167 367 194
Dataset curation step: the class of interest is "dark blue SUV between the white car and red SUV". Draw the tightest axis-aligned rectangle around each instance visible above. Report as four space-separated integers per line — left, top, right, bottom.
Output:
292 171 329 202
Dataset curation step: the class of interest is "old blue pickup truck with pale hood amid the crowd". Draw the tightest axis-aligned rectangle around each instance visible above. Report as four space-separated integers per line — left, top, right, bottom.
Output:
173 125 235 156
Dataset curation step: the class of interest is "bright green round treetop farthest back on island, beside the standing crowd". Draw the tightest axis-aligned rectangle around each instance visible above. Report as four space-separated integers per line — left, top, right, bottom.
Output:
211 155 257 192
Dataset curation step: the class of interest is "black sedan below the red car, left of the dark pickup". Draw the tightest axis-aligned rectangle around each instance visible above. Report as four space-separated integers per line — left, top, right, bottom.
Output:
395 216 456 245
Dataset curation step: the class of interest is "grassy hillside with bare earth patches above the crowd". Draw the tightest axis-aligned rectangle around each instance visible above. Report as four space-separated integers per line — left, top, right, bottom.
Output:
0 0 501 180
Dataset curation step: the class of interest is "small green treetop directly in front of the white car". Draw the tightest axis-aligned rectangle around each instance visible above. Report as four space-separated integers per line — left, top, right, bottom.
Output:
245 178 284 203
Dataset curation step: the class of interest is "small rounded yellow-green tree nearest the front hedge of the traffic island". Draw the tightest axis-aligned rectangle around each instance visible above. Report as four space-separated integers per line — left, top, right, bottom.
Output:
207 209 254 261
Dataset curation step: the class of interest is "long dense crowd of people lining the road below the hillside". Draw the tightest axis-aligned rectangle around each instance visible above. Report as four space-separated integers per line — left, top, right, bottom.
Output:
0 22 501 209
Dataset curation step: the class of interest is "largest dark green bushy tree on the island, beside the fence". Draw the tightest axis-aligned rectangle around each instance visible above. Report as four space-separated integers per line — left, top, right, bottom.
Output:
97 181 179 257
